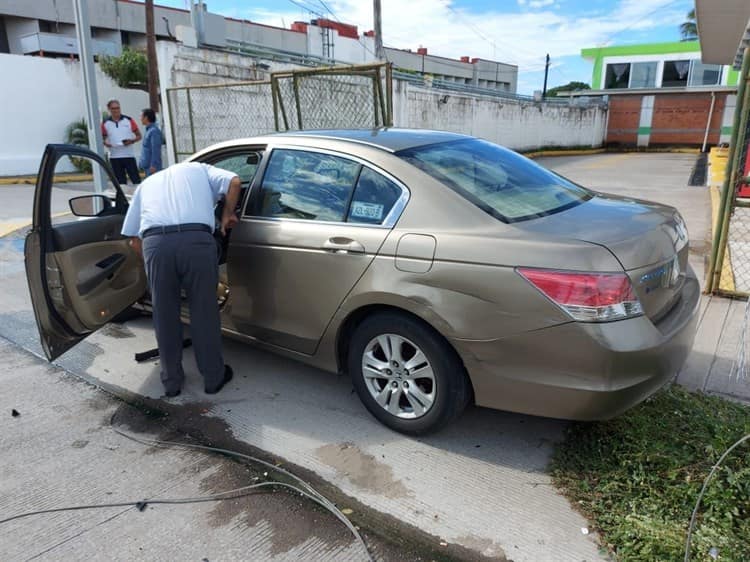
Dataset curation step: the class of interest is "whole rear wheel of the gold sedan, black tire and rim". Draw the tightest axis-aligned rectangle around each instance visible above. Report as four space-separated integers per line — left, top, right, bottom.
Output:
347 312 471 435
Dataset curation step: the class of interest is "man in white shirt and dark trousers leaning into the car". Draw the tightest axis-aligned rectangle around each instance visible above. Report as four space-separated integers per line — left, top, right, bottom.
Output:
122 162 241 398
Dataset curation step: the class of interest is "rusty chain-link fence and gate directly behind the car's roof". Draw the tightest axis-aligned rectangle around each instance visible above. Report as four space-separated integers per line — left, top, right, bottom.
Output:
167 64 393 161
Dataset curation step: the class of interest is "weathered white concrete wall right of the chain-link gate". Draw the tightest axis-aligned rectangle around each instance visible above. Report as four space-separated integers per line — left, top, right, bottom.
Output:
393 81 606 150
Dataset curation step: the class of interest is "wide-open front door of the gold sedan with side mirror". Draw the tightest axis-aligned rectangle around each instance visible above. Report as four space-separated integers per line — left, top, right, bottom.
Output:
24 144 146 360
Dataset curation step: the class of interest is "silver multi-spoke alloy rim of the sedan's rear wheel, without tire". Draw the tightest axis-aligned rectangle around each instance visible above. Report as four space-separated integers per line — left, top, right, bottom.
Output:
362 334 435 419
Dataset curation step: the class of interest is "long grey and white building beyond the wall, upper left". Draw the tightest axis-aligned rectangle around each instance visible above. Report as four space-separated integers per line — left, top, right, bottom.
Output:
0 0 518 93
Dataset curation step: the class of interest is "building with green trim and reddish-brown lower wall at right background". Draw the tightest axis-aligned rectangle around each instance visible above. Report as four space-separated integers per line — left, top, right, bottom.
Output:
579 41 738 147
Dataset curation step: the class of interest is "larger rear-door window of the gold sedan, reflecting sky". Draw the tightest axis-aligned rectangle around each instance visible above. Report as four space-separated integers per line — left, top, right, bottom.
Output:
259 149 360 222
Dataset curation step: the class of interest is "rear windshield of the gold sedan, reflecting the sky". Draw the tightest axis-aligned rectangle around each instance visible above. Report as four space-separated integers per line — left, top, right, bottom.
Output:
397 139 593 222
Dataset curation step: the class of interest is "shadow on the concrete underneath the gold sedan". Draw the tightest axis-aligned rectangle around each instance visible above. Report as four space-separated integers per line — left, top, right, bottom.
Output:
126 319 568 473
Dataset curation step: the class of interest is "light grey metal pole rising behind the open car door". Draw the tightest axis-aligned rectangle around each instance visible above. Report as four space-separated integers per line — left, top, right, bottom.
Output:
73 0 107 193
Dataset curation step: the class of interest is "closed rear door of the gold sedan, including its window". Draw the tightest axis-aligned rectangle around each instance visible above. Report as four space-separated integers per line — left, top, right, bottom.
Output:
227 146 408 355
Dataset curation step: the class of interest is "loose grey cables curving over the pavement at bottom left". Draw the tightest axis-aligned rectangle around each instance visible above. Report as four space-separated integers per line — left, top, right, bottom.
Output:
0 427 374 562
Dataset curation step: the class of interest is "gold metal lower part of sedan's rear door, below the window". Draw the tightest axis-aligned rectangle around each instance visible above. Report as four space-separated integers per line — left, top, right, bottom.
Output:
228 218 390 354
